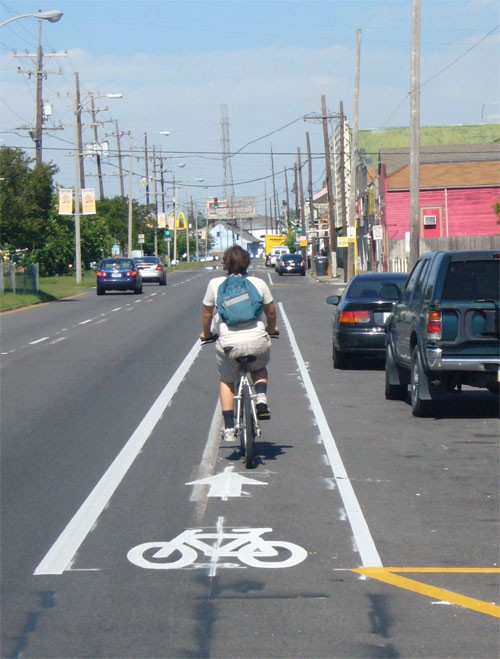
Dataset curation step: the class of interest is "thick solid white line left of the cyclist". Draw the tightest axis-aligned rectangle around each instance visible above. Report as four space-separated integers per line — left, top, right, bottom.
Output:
33 340 201 575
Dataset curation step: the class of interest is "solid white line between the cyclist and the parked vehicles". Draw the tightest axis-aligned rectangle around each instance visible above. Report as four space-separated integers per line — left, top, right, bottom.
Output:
278 302 383 567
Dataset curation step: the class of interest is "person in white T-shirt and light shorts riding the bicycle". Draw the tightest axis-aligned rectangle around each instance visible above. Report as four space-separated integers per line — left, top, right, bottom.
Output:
200 245 278 442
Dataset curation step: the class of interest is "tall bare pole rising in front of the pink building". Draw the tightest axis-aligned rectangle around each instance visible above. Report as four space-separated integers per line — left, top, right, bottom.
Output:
409 0 420 269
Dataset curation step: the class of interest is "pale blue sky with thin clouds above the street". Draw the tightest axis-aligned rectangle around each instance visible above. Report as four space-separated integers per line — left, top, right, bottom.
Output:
0 0 500 213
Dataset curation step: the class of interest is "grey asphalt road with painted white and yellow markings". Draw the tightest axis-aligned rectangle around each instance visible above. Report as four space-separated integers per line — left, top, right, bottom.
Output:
1 269 500 659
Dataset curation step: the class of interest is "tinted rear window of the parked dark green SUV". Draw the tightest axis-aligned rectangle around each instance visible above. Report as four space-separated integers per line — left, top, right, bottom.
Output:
442 261 500 302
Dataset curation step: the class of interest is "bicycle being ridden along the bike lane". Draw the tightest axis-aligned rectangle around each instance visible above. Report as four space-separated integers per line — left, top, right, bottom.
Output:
202 332 279 469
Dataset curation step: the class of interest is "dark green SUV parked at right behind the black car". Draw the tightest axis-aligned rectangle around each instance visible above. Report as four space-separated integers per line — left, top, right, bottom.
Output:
385 250 500 416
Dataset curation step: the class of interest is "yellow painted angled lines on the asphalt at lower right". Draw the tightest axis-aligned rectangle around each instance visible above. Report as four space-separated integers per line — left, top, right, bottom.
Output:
352 567 500 618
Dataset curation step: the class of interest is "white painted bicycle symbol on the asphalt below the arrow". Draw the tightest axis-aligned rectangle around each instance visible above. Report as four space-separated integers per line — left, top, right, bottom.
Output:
127 526 307 574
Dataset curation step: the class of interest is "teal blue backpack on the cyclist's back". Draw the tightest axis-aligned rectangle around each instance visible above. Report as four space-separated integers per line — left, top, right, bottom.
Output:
217 275 263 327
